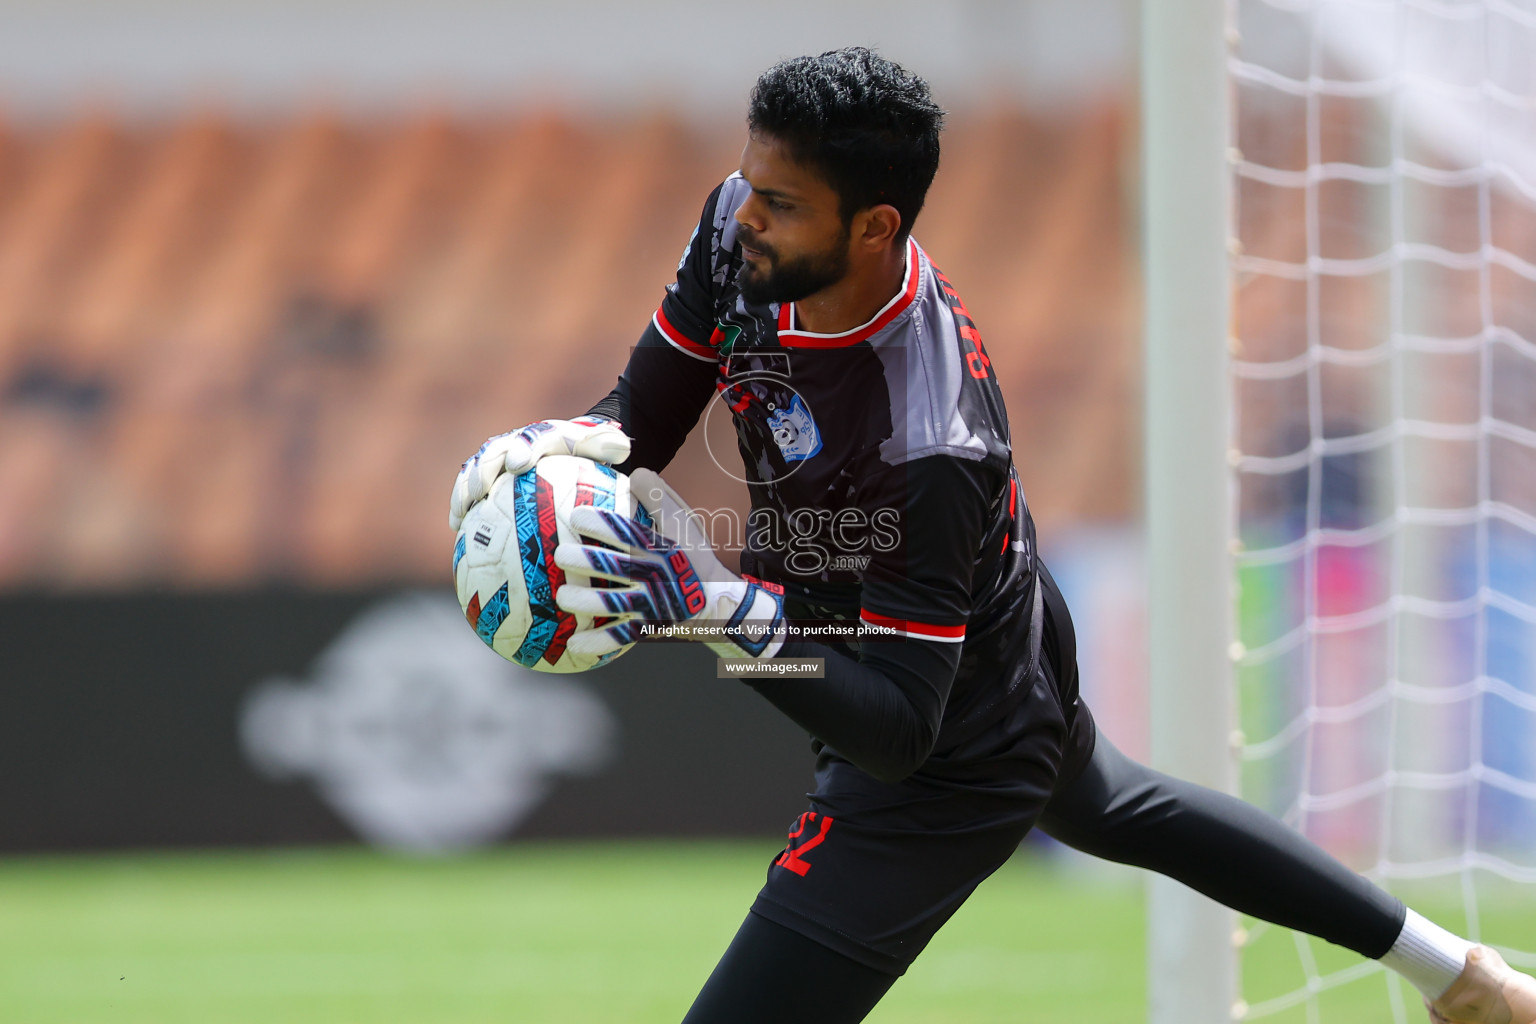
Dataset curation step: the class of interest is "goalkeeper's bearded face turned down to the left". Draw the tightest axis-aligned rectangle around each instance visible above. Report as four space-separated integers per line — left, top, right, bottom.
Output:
736 135 852 306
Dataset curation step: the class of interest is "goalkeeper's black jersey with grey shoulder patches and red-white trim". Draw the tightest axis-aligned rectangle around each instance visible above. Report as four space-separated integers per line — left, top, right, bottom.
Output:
591 173 1040 780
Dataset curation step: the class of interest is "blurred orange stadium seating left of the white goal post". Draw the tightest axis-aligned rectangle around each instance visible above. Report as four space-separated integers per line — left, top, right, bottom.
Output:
0 106 1140 588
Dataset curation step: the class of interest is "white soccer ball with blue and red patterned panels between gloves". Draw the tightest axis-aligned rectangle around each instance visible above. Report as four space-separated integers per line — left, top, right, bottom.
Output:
453 454 651 672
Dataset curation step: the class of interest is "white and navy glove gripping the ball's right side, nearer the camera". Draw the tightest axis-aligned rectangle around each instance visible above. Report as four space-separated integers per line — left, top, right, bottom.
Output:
554 470 785 659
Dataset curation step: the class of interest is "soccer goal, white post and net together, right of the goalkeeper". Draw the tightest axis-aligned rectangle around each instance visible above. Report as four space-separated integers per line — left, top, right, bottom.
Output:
1141 0 1536 1024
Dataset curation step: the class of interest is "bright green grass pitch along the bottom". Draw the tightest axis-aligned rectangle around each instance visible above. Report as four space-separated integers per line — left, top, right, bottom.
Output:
0 840 1531 1024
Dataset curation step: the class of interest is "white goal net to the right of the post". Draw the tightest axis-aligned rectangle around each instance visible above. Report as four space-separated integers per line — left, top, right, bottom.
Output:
1229 0 1536 1022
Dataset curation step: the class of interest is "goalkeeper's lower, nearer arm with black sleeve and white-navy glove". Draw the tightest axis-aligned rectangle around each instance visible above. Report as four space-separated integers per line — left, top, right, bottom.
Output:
554 457 995 781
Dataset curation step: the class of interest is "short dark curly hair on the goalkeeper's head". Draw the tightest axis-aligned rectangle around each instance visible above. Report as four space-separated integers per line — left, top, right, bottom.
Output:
746 46 945 239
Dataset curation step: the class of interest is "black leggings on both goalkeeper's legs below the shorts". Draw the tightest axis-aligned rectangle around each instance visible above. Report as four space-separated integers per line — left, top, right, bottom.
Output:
684 734 1407 1024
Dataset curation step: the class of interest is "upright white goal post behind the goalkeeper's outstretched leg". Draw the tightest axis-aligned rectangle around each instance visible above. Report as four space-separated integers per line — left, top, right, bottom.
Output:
1141 0 1236 1024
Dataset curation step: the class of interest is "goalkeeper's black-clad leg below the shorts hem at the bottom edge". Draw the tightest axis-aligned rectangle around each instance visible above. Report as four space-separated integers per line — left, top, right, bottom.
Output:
684 913 895 1024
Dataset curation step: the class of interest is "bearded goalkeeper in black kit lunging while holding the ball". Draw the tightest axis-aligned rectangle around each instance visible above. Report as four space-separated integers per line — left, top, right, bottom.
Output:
450 48 1536 1024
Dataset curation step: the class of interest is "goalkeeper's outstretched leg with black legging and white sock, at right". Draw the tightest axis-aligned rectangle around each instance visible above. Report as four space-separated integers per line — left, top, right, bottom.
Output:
1040 734 1536 1024
